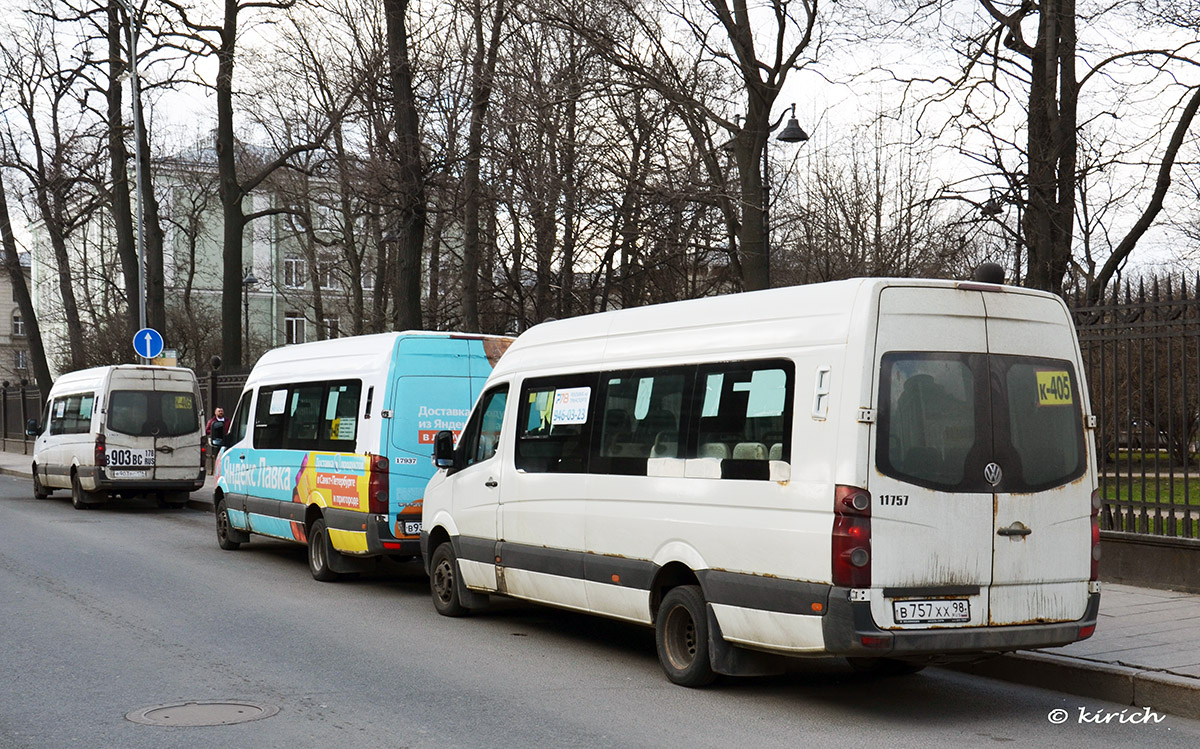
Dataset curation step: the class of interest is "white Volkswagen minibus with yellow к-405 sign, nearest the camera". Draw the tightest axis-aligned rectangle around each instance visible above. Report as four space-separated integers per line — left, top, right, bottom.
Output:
421 278 1099 685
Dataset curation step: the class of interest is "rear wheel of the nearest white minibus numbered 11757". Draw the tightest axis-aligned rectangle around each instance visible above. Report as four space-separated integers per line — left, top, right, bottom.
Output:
654 586 716 687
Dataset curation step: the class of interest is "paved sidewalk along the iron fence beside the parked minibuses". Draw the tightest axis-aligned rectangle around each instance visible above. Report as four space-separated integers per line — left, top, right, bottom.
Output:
0 451 1200 719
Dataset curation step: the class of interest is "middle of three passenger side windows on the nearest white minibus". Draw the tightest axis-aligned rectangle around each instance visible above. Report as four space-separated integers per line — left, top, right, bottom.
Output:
594 367 695 475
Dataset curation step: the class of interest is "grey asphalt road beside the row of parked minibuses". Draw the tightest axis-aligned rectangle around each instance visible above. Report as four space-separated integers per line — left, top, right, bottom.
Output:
7 477 1200 749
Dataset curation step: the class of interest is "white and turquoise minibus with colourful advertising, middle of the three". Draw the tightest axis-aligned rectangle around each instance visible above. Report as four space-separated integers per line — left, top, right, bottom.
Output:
212 331 511 582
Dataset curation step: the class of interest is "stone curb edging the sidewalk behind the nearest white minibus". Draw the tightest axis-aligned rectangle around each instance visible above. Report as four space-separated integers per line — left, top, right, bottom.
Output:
944 651 1200 720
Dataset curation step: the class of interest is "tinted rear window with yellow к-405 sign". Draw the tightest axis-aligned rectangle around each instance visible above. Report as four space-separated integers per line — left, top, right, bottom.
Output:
876 353 1086 492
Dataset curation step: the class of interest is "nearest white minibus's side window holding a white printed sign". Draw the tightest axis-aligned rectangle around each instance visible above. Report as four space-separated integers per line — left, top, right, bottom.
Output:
516 375 595 473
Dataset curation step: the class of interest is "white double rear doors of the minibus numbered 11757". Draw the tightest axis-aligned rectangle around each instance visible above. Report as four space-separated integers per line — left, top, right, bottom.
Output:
870 287 1091 629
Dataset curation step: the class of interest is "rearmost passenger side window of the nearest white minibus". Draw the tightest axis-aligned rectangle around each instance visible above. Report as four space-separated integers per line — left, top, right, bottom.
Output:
695 360 796 480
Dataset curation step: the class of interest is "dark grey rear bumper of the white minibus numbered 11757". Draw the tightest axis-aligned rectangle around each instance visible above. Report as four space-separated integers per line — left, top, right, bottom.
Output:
822 588 1100 658
